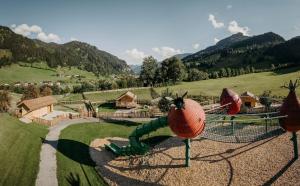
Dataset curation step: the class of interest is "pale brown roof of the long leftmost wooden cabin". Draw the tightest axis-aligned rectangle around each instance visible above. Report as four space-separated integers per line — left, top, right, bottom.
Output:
17 96 57 111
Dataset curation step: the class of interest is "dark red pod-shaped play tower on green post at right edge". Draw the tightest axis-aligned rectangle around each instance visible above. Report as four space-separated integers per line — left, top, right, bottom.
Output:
280 80 300 159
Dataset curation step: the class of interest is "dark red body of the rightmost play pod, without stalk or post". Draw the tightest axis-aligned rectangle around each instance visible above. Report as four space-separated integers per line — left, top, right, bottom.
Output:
280 91 300 132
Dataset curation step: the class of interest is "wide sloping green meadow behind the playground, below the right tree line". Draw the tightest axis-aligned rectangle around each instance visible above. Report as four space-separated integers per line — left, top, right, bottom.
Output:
64 71 300 101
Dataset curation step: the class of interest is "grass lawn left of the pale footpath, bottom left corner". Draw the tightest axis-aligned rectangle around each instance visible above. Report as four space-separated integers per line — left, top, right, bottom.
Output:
0 114 48 185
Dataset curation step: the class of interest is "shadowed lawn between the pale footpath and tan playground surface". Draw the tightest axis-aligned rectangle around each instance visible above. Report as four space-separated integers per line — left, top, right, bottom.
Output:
57 122 170 186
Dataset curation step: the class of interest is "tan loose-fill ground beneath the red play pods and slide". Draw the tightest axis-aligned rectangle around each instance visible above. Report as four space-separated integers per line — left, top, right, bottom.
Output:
90 132 300 186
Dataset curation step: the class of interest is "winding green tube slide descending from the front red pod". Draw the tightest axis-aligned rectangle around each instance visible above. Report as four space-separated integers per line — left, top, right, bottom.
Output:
105 117 168 156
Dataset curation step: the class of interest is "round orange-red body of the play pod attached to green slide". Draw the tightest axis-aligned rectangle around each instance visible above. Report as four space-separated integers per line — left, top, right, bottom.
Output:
168 99 205 138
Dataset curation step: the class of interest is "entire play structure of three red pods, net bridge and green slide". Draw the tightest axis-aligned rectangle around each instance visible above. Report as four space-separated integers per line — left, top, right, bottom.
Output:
105 81 300 166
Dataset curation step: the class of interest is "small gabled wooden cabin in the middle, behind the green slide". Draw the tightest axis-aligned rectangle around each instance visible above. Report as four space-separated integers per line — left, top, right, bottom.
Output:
116 91 137 108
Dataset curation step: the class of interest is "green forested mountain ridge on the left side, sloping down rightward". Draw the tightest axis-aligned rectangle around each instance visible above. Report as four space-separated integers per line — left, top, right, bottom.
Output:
0 26 131 75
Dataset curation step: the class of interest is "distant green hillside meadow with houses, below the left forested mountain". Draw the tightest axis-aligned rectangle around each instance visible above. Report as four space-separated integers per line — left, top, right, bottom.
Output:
0 64 97 83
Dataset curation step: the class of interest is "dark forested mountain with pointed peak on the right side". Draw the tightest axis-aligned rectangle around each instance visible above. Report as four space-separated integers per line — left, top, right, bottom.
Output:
182 32 286 71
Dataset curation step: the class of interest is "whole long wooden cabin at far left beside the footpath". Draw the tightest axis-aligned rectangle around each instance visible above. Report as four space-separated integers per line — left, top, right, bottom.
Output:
17 96 57 120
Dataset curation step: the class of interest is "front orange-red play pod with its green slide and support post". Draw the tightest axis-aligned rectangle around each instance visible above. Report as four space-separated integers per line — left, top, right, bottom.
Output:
105 92 211 166
